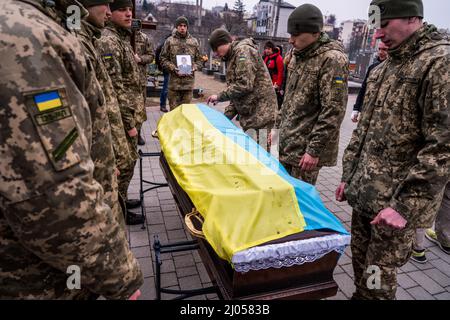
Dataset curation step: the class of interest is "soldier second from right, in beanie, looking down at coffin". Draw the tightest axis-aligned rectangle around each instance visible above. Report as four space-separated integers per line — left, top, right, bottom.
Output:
278 4 348 185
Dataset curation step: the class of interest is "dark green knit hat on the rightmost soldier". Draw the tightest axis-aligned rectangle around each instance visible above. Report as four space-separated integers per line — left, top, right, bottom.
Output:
369 0 423 20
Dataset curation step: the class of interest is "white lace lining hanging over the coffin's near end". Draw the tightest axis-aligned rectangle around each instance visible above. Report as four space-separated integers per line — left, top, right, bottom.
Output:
232 234 350 273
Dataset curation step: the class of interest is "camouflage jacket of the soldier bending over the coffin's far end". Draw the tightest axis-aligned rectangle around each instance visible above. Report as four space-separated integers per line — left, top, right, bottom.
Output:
218 39 278 130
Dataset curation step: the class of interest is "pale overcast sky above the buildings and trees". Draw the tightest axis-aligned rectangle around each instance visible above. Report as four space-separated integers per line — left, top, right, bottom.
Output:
203 0 450 29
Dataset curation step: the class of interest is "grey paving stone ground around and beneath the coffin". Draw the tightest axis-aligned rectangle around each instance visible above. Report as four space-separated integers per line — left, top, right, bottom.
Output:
125 74 450 300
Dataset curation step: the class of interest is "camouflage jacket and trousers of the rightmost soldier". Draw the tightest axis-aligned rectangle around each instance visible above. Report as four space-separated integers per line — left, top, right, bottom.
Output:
342 24 450 299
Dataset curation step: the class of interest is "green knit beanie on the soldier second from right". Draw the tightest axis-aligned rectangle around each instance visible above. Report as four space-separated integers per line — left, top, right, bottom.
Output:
288 3 323 35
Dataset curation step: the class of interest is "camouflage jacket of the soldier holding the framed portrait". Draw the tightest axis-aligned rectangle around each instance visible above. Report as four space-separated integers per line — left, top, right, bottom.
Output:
160 29 203 90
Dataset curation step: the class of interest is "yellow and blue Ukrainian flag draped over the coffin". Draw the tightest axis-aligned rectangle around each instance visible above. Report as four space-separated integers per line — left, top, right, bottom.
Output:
158 104 347 261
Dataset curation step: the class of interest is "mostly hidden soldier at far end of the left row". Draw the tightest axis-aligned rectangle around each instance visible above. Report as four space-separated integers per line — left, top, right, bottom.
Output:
135 31 155 146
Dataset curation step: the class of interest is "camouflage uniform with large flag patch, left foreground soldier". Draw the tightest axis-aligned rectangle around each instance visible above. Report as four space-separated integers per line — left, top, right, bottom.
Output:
0 0 143 299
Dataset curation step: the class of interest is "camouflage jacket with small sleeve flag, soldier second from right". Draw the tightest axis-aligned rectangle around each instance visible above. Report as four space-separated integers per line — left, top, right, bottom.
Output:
279 34 348 167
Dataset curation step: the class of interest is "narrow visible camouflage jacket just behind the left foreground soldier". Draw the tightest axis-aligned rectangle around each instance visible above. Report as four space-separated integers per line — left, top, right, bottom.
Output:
83 22 138 170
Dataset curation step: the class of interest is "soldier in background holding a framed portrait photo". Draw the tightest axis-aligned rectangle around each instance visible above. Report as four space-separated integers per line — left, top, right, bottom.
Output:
160 17 202 110
